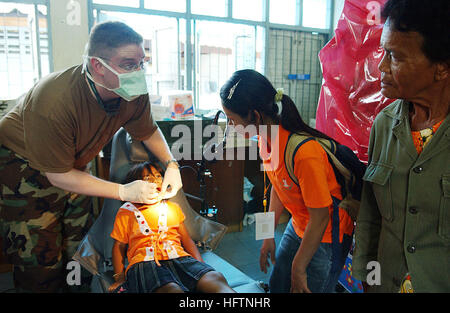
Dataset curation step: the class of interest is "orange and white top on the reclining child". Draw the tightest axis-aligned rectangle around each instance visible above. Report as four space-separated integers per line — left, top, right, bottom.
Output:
111 201 190 270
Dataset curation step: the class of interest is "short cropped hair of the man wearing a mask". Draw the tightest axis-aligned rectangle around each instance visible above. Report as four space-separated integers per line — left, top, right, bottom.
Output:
87 21 143 57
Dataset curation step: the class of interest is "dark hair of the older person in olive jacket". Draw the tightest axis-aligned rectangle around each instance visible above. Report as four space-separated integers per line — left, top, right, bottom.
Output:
381 0 450 63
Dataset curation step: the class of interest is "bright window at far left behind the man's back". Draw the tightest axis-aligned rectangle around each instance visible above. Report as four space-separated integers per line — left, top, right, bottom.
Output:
0 1 50 100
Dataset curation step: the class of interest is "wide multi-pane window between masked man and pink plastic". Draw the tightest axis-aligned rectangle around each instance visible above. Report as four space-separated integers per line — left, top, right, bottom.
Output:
89 0 332 116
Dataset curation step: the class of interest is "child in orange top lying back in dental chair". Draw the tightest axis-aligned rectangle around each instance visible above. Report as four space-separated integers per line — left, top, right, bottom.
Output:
109 162 234 293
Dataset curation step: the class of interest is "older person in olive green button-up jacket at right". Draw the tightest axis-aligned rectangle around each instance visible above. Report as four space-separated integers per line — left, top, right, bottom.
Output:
353 0 450 292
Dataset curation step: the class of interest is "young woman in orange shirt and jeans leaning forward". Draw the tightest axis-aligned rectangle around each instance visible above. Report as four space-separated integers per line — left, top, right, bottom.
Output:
220 70 353 292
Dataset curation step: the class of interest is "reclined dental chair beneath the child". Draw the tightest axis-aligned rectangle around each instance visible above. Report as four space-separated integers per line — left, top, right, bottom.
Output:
73 128 265 293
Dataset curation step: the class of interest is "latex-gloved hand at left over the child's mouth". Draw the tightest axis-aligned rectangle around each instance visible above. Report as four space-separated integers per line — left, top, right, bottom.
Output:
119 180 158 204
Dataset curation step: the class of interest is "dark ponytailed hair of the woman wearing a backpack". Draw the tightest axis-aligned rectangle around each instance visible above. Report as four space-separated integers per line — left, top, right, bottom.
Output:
220 70 331 139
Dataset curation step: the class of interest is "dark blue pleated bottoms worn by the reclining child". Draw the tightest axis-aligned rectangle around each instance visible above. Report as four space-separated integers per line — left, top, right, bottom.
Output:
126 256 214 293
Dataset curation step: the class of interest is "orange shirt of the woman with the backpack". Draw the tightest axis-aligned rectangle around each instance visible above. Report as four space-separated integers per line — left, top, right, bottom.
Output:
260 125 354 243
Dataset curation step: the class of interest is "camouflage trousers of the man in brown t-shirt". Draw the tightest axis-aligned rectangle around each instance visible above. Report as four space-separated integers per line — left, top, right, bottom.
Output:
0 145 93 292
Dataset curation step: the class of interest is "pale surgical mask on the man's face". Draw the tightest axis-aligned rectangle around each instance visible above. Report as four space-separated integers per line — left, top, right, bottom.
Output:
85 56 148 101
